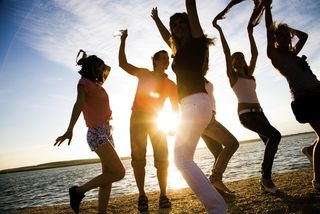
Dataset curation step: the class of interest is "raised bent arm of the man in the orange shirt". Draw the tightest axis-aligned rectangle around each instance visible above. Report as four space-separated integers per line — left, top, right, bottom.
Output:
119 30 141 76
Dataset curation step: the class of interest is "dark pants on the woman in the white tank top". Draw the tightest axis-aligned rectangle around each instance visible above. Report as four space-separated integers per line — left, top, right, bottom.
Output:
239 112 281 179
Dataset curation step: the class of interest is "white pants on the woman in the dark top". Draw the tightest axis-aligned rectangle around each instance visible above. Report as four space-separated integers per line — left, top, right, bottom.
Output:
174 93 227 214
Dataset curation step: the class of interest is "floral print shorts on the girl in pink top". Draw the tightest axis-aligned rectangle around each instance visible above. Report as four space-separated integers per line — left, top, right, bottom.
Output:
87 122 114 151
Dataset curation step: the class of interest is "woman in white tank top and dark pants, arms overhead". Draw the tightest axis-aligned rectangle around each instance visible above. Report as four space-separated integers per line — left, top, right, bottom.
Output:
212 10 283 193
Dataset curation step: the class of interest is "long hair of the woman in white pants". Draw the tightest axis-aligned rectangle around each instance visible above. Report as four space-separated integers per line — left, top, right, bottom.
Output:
169 12 214 56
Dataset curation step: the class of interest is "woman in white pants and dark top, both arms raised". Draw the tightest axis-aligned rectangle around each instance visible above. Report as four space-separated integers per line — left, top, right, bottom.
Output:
151 0 227 213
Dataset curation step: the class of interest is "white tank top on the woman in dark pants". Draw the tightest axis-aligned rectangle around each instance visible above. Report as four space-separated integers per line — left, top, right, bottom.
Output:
232 77 259 103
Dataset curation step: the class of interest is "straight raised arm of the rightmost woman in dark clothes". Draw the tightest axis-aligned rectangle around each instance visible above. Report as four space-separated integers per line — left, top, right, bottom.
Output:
264 0 275 58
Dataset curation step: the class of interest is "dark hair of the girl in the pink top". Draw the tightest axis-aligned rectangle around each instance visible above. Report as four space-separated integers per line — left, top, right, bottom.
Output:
77 50 104 83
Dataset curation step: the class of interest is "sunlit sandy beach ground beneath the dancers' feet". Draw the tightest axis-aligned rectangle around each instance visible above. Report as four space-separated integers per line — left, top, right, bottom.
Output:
15 169 320 214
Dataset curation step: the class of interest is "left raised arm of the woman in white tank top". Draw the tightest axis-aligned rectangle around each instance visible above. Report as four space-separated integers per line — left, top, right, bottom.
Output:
212 16 237 86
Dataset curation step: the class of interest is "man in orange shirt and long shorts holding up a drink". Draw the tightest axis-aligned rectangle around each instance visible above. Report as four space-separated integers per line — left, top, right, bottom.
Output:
119 30 178 212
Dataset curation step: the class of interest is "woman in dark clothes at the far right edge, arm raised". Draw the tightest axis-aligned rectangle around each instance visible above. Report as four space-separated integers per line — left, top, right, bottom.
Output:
265 0 320 190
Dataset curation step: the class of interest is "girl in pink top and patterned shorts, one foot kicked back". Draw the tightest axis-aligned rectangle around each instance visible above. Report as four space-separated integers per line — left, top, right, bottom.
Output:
54 50 125 213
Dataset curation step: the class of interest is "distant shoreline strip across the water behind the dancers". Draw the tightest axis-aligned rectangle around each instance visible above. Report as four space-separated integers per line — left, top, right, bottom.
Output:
0 131 314 174
